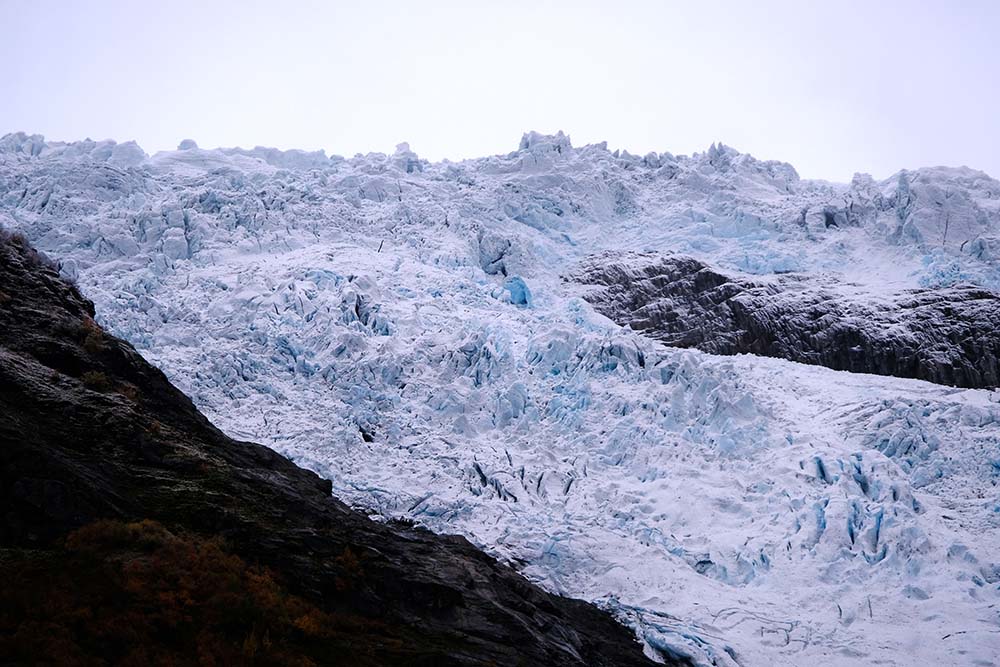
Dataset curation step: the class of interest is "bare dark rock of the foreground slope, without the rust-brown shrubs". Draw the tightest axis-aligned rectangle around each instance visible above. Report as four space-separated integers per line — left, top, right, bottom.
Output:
0 235 664 665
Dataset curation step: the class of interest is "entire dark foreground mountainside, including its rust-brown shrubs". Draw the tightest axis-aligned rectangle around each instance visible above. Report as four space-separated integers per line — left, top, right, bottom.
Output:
0 232 672 666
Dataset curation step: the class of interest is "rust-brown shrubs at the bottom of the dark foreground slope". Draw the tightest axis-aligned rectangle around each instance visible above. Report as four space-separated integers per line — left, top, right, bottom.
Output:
0 521 398 666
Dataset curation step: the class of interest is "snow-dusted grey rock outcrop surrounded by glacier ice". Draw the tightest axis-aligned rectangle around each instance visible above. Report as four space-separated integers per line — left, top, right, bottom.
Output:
570 253 1000 388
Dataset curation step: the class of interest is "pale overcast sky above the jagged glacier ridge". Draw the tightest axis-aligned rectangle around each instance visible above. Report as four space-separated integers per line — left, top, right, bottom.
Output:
0 0 1000 181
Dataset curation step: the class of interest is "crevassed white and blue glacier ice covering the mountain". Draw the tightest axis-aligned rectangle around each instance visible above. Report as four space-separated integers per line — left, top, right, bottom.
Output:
0 133 1000 665
